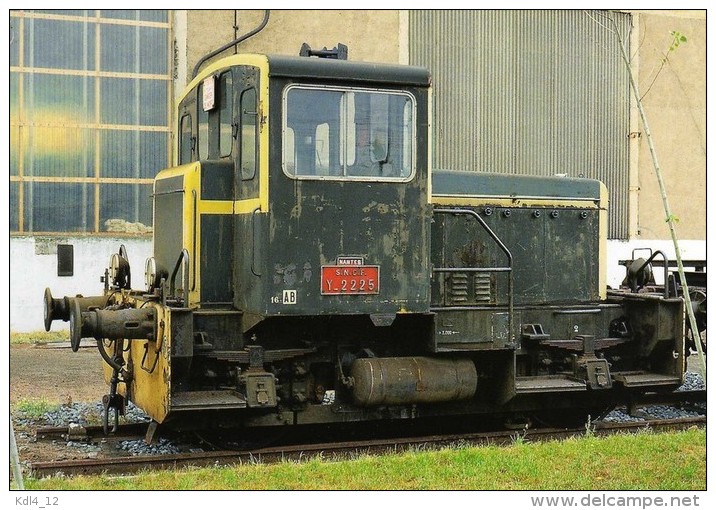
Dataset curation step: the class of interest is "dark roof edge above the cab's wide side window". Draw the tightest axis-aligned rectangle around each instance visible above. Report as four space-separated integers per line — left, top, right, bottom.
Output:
268 55 431 87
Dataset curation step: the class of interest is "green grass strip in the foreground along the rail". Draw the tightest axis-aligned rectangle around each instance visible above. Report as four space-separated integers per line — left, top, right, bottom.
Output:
16 429 706 491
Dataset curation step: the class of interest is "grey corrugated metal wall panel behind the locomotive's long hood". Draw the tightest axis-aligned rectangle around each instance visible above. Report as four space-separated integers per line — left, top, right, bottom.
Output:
410 10 631 239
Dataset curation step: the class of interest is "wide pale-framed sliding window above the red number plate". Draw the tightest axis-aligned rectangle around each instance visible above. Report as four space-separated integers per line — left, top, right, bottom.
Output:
283 85 415 181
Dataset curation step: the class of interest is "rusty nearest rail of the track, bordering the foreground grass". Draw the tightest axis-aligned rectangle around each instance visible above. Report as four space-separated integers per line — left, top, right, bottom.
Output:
29 416 706 478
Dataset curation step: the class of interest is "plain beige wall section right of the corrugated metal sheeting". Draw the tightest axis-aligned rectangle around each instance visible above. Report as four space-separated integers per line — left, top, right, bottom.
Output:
632 11 706 241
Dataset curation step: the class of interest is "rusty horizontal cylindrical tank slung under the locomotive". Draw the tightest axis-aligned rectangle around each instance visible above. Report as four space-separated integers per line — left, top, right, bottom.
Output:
351 357 477 406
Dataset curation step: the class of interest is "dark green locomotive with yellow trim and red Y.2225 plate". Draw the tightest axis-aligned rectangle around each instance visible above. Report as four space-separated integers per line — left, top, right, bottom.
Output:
44 43 685 436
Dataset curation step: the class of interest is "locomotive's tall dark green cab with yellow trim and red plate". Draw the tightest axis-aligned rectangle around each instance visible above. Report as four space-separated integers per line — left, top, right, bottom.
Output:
160 55 429 322
